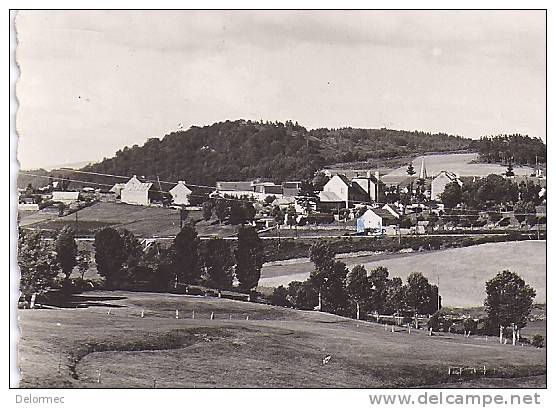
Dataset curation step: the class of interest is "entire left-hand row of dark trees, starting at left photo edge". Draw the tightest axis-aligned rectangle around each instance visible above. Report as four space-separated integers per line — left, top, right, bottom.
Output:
18 225 264 297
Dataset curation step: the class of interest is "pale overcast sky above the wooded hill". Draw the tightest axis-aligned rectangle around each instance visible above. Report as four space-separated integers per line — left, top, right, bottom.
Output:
16 11 546 168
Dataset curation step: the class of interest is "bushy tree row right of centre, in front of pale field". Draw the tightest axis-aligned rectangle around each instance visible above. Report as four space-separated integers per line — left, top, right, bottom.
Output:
271 241 440 319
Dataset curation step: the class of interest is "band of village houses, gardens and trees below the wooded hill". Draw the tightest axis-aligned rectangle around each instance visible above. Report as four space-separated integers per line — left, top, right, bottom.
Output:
19 159 546 235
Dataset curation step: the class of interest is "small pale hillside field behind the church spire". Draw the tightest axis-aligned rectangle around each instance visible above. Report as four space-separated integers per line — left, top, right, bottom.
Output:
384 153 535 180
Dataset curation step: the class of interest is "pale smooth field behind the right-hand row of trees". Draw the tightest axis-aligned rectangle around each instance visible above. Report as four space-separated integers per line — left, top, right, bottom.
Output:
259 241 546 307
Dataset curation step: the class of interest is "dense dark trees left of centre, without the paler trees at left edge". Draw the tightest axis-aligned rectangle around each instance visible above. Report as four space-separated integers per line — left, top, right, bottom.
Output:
94 225 264 292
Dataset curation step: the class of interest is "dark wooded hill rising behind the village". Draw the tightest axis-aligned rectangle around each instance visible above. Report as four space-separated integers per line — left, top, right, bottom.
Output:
73 120 471 185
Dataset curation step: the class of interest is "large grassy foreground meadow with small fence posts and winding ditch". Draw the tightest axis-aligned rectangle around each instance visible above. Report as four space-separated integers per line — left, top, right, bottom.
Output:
18 292 546 388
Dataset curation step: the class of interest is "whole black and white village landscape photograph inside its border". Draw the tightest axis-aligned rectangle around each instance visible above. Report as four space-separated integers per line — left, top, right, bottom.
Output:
10 9 548 396
